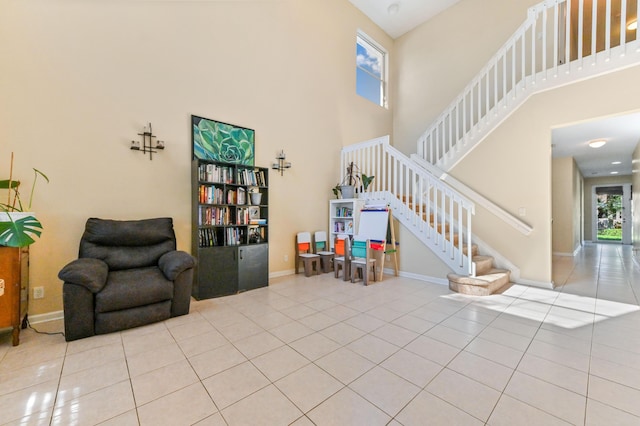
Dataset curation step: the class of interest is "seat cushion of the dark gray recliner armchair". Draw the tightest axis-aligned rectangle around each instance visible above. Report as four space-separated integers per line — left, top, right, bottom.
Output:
95 266 173 313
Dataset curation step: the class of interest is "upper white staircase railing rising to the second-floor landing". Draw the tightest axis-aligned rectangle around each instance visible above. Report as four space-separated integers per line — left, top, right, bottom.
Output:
418 0 640 171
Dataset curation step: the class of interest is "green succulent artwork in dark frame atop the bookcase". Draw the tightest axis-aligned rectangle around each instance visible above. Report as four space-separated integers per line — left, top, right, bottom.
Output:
191 115 255 166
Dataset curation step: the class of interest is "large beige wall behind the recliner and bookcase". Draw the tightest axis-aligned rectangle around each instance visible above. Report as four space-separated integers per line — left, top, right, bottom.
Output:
0 0 393 315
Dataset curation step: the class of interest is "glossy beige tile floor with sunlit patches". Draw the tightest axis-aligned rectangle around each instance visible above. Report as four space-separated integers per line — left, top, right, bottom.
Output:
0 245 640 426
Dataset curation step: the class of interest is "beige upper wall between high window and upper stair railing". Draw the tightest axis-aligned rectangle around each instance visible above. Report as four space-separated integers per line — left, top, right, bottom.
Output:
392 0 540 155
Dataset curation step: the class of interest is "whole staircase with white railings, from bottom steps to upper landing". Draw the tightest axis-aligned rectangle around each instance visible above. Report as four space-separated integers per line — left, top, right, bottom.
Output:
341 0 640 295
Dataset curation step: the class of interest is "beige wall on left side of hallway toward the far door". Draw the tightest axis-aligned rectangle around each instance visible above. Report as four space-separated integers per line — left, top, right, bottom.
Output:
551 157 582 255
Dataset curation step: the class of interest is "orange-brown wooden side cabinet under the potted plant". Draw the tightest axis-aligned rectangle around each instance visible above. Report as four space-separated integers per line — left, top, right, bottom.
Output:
0 246 29 346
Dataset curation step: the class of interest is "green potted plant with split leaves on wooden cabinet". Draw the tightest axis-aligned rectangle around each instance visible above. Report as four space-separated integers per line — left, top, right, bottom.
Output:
0 153 49 247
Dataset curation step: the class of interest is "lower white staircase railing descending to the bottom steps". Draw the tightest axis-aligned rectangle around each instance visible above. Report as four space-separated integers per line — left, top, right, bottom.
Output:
341 136 475 276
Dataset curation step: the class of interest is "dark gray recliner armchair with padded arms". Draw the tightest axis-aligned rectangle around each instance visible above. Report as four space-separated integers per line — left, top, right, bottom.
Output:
58 218 195 341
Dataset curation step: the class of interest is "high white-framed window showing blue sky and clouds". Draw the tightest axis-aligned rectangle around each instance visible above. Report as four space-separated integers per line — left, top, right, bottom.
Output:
356 31 387 107
